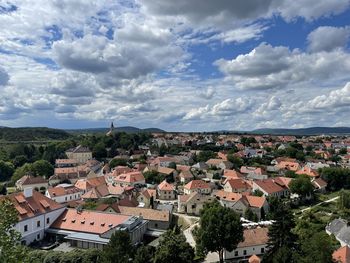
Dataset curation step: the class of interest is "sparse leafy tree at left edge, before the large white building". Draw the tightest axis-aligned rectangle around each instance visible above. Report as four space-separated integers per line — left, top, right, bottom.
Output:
0 199 24 263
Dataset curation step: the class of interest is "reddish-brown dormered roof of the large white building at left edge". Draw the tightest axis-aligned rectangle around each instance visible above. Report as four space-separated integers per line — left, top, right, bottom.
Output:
0 190 63 221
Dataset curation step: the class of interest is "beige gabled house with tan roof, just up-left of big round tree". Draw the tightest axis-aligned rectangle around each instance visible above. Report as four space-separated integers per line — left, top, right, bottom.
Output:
178 192 215 216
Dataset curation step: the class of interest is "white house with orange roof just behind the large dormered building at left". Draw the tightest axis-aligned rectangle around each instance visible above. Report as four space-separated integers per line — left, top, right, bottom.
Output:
45 184 83 204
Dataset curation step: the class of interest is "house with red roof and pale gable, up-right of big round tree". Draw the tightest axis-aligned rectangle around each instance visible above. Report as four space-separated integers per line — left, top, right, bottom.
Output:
253 178 290 197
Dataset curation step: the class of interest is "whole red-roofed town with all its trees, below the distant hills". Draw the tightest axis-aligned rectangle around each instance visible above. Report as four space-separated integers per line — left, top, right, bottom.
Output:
0 123 350 262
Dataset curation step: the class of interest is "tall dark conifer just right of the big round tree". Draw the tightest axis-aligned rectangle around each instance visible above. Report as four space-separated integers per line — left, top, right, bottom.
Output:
264 202 297 262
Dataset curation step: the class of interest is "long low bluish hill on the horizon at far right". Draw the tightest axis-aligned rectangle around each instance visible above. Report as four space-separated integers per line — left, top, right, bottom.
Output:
251 127 350 135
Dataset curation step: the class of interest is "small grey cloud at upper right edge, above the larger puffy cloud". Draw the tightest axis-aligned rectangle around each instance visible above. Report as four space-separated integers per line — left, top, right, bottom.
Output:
307 26 350 52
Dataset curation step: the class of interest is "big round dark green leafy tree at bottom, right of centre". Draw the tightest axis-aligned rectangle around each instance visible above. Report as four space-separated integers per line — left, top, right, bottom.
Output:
195 201 243 262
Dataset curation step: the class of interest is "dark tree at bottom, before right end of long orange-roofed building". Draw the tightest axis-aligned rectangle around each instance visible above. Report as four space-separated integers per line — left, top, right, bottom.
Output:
102 230 133 263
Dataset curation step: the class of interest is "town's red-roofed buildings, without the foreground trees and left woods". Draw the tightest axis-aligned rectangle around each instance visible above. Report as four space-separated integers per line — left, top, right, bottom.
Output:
0 124 350 263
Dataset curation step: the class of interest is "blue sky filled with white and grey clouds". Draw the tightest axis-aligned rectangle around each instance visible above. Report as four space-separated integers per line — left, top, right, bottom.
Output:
0 0 350 131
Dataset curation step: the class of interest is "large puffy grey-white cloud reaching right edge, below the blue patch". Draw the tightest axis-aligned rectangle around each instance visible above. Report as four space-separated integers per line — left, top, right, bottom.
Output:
214 43 350 90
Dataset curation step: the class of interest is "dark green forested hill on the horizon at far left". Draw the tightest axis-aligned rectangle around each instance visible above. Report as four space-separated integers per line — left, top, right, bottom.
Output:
0 127 71 141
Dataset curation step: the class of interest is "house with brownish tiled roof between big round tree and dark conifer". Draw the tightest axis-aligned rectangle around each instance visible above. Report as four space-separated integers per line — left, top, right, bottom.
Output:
224 227 269 262
